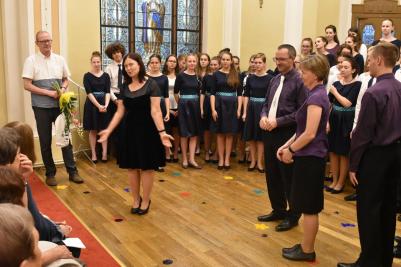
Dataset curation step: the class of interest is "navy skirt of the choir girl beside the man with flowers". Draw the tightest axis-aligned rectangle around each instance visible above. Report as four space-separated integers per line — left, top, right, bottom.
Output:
83 94 110 131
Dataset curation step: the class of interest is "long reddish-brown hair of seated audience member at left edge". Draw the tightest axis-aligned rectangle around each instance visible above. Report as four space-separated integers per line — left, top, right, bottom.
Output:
4 121 36 163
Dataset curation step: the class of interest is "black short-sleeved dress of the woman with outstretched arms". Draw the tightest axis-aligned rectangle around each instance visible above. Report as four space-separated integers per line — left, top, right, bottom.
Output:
117 79 166 170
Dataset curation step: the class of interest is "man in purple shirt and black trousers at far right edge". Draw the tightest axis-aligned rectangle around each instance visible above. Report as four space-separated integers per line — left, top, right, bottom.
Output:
337 43 401 267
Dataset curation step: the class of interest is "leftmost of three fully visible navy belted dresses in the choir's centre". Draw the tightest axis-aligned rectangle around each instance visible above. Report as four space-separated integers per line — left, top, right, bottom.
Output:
174 72 202 137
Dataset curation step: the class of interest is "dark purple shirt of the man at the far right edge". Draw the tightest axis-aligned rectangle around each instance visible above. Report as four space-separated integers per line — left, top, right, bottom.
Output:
350 73 401 172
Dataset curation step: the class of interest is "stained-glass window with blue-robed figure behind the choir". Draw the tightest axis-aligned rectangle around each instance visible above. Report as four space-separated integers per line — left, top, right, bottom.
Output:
100 0 202 66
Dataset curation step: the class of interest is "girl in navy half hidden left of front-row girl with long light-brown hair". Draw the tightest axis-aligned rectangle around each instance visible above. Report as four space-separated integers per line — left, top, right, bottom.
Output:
200 57 220 162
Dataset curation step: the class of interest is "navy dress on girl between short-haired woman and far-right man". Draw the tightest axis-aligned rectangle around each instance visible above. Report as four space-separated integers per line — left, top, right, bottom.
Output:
328 81 361 156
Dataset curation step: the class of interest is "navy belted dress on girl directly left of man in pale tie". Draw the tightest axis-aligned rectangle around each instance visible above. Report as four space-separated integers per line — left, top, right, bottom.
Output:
243 74 273 141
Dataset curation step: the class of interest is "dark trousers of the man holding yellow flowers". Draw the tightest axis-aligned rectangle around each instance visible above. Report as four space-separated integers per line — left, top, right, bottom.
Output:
32 107 77 177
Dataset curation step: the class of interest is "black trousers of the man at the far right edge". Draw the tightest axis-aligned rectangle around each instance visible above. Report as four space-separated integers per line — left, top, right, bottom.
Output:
357 143 401 267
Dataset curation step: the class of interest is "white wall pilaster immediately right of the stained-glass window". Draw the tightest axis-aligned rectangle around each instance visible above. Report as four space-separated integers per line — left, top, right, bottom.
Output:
222 0 241 57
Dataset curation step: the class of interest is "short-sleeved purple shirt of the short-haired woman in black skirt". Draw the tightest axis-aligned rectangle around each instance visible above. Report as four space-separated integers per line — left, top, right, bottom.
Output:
295 84 330 158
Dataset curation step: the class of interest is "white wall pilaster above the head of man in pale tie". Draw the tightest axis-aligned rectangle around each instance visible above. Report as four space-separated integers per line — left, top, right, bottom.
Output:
283 0 304 47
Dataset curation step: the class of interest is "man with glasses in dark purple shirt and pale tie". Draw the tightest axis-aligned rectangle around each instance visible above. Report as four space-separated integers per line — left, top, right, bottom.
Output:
258 44 307 231
